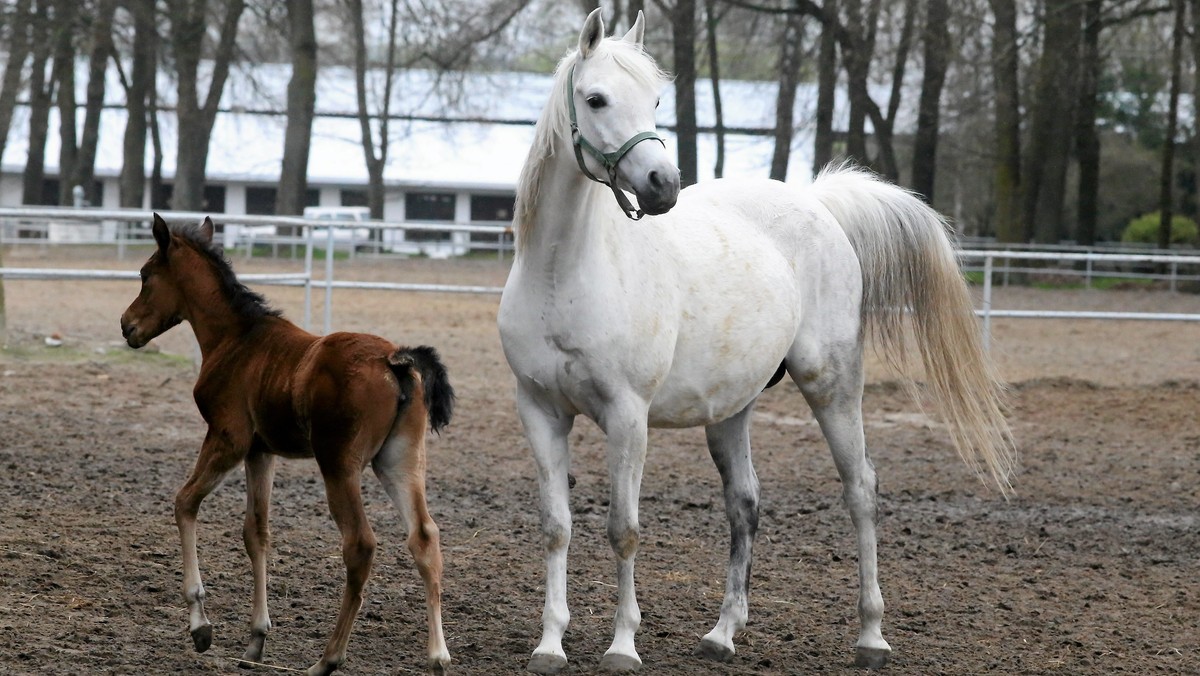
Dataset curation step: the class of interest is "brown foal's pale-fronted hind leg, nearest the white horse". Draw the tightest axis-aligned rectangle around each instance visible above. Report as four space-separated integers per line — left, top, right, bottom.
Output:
371 422 450 674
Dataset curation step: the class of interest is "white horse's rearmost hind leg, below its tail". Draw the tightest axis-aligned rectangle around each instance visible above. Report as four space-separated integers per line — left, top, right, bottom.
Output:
792 347 892 669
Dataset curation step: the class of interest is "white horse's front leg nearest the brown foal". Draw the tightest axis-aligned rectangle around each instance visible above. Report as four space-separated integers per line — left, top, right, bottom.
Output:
517 388 575 674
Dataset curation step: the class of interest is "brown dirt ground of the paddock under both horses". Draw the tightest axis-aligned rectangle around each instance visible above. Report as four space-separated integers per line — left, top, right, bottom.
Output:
0 247 1200 675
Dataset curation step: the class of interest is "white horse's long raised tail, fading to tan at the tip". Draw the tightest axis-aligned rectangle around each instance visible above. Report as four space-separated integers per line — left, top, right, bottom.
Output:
811 164 1016 496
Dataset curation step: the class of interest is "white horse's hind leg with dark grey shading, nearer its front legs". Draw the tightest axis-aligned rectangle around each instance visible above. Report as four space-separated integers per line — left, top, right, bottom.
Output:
696 403 758 662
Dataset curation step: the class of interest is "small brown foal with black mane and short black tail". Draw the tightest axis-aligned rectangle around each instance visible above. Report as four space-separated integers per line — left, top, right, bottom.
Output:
121 214 454 675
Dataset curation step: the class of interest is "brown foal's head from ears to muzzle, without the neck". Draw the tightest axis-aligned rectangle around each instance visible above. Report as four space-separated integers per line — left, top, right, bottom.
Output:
121 214 212 348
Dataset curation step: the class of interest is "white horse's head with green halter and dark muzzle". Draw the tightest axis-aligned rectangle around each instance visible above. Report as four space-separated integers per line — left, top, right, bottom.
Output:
566 10 679 214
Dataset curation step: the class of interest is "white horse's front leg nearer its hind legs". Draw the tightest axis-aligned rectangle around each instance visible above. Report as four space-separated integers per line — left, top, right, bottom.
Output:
600 405 648 671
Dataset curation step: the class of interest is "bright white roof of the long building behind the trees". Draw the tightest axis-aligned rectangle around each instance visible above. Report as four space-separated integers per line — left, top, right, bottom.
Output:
2 62 892 191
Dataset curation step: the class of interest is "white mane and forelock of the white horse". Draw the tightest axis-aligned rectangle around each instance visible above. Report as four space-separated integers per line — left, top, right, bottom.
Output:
512 37 671 252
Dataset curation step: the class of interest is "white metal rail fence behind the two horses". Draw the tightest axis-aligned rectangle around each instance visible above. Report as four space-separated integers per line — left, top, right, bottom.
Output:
0 208 1200 345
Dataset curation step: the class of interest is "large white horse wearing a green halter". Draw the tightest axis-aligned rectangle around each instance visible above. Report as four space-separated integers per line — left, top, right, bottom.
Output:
498 10 1015 674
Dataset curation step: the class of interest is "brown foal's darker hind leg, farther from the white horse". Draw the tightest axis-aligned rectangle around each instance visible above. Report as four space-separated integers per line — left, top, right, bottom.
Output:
307 465 376 676
